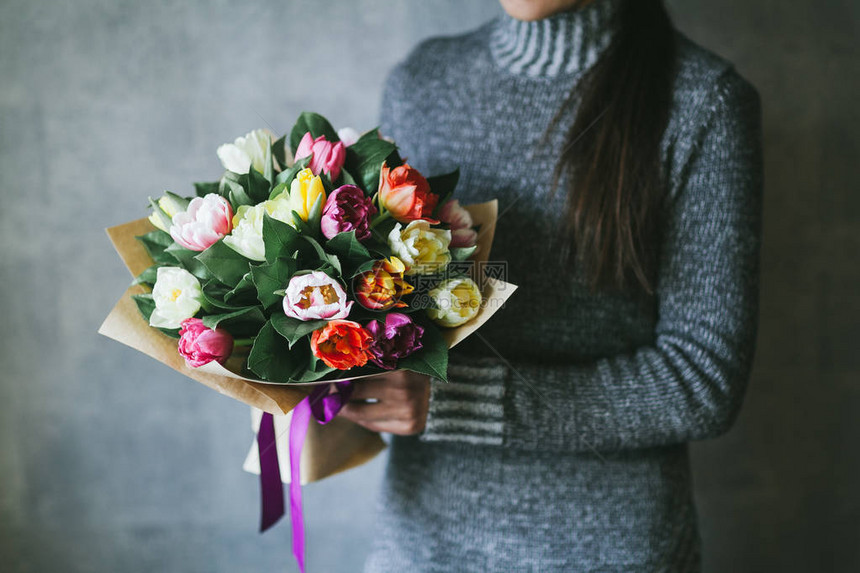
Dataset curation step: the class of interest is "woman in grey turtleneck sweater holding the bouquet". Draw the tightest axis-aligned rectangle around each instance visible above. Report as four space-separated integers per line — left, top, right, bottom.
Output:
343 0 761 572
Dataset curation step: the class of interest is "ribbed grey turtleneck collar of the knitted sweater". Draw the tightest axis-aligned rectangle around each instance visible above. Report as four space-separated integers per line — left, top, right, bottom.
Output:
490 0 619 77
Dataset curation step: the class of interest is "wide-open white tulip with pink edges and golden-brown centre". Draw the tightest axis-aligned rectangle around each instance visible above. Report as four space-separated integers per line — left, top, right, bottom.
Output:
284 271 352 320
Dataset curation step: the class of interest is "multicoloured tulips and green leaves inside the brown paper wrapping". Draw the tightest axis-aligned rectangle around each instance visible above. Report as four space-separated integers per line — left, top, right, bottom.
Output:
112 113 510 384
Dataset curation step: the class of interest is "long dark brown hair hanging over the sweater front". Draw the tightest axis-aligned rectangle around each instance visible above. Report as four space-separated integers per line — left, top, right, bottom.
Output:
553 0 675 295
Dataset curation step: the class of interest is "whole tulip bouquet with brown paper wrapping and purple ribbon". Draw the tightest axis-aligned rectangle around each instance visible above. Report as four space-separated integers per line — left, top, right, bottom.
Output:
99 113 516 569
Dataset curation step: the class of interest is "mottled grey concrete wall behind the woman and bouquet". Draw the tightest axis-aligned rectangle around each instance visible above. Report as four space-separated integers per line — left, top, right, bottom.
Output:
0 0 860 573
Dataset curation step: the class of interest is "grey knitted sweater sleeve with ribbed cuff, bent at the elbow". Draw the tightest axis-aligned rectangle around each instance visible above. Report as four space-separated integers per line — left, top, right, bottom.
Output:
421 72 762 452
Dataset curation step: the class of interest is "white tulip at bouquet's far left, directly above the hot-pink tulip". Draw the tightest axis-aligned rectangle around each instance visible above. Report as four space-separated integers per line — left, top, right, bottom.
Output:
149 267 203 328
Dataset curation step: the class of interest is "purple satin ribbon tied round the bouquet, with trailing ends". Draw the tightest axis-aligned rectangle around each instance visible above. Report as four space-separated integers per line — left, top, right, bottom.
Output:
257 382 352 573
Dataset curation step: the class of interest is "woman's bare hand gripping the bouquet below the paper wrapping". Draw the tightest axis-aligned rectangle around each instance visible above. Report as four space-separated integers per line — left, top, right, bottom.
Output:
340 370 430 436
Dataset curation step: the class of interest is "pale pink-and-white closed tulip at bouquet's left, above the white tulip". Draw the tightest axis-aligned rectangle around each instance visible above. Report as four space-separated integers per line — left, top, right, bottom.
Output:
170 193 233 251
